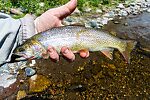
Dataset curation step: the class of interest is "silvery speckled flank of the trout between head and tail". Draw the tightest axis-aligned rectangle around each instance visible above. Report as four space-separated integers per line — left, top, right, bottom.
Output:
37 26 120 51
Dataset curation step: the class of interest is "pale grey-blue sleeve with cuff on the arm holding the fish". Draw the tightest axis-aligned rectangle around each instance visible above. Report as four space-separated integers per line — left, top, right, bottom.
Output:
0 13 35 65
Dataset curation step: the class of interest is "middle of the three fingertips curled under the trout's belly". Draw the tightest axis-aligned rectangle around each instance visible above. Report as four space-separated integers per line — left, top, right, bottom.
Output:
61 46 75 61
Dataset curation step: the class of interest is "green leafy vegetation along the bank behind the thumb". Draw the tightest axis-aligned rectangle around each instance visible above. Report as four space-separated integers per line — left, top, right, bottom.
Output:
0 0 125 15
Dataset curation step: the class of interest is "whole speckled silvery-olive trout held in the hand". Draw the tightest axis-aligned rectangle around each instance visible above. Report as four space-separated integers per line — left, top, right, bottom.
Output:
14 26 136 63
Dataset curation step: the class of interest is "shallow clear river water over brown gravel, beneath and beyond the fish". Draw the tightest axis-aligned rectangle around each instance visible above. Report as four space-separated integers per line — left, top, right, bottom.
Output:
2 13 150 100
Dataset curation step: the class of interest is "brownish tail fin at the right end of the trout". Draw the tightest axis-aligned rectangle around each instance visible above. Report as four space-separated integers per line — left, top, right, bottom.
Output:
121 40 137 63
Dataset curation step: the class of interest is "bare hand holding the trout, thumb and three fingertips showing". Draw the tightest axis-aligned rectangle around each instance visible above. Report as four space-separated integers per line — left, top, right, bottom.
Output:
35 0 89 60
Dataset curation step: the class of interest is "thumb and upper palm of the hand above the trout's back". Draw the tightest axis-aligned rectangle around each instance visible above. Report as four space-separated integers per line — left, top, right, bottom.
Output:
34 0 77 33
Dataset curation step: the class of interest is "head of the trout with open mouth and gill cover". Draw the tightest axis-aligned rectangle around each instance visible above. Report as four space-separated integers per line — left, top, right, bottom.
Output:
13 39 46 61
